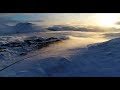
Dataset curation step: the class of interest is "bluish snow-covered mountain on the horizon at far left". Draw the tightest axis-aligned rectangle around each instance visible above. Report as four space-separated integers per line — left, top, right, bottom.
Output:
0 23 48 35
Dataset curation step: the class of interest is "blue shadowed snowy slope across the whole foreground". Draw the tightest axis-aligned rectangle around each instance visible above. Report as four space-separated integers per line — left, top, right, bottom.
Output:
0 38 120 77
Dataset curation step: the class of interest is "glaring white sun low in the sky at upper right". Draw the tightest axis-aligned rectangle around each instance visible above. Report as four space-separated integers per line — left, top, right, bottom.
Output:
96 13 118 27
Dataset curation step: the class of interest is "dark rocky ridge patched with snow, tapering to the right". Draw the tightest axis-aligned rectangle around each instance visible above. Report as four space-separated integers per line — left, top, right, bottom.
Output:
0 37 65 56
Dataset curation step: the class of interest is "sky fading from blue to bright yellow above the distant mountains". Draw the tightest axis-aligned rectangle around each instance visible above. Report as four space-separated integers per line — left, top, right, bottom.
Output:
0 13 120 27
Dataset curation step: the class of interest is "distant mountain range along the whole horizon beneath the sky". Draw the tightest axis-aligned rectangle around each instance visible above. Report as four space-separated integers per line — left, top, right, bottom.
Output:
0 22 116 35
